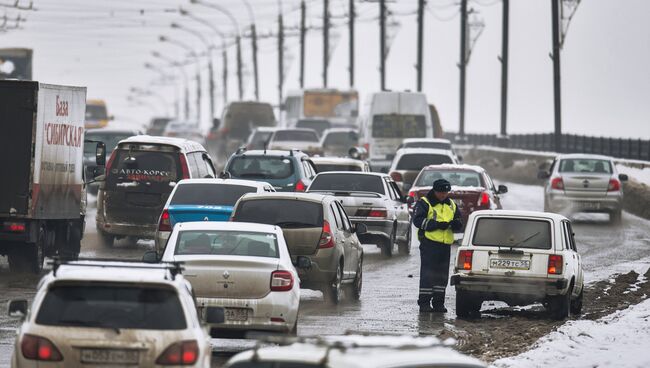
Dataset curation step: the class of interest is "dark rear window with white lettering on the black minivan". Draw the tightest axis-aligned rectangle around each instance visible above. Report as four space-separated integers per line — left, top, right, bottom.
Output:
106 149 182 190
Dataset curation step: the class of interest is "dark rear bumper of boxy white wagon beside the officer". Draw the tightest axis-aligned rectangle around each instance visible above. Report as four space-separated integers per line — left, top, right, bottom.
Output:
450 274 569 299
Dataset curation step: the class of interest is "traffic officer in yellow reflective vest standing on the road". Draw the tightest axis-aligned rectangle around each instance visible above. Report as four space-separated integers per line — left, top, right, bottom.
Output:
413 179 463 313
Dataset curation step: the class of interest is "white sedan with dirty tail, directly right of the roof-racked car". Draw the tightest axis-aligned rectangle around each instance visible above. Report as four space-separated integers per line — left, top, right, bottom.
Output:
162 221 300 337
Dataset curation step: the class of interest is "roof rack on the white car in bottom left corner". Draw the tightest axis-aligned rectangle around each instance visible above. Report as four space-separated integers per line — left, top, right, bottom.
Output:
48 256 184 280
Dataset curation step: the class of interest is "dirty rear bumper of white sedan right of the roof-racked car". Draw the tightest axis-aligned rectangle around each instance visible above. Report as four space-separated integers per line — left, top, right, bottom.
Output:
196 288 300 332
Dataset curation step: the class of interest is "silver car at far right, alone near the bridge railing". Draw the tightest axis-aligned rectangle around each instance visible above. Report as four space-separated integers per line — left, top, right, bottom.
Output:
537 154 627 223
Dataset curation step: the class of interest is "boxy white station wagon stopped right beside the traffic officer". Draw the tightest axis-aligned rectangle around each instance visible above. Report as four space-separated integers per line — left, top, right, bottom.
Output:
451 210 584 320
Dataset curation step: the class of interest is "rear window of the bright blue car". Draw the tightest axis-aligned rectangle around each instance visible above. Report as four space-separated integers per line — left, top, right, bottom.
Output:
170 184 257 206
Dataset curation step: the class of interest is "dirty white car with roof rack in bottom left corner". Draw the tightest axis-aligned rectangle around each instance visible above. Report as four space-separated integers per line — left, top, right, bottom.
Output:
9 261 211 368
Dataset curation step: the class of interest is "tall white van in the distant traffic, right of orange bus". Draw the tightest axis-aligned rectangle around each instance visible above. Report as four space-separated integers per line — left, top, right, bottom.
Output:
359 92 433 172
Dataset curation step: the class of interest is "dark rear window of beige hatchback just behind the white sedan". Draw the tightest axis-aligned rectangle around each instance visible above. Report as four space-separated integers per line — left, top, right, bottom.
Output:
233 199 323 227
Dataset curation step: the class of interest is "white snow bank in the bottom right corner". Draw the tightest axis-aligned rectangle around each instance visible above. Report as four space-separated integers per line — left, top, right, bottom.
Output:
492 299 650 368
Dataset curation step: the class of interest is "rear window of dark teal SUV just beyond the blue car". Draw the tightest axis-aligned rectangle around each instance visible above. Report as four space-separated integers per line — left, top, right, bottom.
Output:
226 156 294 179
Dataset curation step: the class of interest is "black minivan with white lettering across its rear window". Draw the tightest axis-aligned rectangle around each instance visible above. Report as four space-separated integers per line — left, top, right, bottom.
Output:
96 135 215 246
